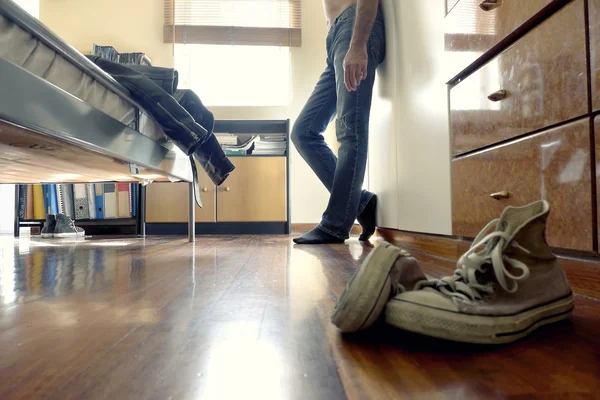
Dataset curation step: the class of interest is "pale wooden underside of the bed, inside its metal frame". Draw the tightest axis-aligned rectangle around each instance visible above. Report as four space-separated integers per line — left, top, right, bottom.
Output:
0 121 172 183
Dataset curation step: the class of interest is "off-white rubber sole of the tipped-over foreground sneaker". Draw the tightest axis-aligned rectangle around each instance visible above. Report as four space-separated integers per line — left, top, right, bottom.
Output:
331 242 402 333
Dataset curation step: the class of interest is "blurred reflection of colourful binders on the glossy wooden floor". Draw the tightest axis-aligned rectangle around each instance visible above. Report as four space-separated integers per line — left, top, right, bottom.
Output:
0 238 145 305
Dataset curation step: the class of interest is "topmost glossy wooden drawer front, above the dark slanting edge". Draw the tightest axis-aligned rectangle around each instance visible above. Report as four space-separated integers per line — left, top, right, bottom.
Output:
445 0 552 79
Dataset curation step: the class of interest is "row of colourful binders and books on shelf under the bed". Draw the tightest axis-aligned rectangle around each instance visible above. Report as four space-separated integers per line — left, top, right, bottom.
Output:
19 183 139 220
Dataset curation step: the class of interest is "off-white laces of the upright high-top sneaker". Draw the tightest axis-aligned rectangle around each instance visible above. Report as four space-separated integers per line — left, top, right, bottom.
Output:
417 219 530 301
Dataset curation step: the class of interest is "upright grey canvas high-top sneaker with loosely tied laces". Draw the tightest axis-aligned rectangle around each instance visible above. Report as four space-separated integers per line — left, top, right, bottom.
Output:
385 201 573 343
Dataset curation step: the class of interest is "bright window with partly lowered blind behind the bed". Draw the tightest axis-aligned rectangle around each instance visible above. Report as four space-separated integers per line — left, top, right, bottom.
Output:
164 0 302 106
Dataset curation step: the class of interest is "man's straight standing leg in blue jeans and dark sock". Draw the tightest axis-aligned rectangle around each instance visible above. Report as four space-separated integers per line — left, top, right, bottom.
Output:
295 6 385 244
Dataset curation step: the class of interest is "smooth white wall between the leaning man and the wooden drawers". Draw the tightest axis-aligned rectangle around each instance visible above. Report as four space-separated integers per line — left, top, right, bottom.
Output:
369 0 452 234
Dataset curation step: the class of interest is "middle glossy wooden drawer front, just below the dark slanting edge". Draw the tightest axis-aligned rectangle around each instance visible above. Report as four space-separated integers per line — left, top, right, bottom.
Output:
450 0 588 155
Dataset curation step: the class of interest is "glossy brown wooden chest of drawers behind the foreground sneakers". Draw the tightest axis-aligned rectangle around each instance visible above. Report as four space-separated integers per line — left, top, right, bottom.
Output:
446 0 600 252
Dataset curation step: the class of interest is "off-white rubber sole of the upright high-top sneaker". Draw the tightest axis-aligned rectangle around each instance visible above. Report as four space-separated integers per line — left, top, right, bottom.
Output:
385 295 573 344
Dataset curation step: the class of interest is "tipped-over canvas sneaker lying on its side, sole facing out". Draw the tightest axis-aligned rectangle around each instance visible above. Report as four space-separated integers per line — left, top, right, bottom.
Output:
331 242 427 333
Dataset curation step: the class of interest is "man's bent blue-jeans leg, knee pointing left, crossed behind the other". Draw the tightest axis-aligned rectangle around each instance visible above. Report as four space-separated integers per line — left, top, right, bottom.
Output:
292 57 373 222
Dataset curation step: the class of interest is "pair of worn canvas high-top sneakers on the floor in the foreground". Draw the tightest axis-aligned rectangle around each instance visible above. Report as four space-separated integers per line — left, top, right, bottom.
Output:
331 201 573 344
